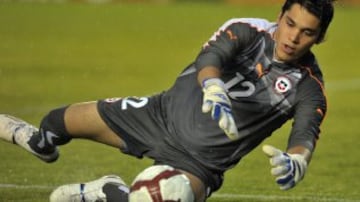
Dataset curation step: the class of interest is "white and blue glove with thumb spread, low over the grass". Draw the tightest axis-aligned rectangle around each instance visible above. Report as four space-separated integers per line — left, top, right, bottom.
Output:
262 145 307 190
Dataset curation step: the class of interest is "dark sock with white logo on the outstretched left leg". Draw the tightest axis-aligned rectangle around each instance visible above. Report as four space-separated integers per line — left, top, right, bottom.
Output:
29 107 71 153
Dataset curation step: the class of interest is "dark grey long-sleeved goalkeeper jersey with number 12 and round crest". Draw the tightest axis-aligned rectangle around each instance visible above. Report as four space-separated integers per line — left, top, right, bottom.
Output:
162 18 326 171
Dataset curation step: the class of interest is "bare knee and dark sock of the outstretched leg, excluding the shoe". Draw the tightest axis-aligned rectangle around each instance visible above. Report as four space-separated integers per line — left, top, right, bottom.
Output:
29 102 125 151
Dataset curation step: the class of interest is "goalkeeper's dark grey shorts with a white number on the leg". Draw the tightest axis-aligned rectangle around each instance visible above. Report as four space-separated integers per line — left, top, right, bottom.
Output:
98 94 223 196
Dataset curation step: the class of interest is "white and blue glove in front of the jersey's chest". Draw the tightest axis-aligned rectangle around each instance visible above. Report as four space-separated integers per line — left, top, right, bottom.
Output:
202 78 239 140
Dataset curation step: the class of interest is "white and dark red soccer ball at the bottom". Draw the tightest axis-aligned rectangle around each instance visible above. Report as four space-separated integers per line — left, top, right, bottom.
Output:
129 165 194 202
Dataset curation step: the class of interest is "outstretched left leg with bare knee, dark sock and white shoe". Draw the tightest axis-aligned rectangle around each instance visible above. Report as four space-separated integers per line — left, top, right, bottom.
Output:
0 102 125 163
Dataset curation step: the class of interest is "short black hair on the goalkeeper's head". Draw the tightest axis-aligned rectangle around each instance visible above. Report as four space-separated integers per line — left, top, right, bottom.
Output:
281 0 336 43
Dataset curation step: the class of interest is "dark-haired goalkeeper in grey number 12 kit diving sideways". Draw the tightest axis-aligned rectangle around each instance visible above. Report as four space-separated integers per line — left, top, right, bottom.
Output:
0 0 333 201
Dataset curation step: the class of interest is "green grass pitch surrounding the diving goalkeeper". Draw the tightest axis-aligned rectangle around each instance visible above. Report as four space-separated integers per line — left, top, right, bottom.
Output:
0 3 360 202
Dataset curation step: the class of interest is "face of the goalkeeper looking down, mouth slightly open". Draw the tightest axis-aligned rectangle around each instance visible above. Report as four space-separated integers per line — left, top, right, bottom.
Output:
274 4 320 62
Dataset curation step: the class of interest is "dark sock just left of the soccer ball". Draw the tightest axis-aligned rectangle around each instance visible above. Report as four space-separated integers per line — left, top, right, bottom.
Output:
102 182 129 202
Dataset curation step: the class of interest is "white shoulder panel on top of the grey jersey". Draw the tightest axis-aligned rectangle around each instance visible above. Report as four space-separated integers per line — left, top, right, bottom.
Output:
221 18 277 33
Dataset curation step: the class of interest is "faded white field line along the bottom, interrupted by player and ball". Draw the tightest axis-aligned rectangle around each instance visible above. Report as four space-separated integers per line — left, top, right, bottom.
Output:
0 184 360 202
